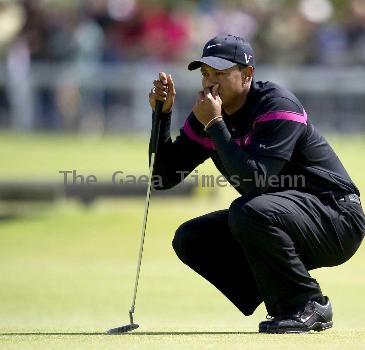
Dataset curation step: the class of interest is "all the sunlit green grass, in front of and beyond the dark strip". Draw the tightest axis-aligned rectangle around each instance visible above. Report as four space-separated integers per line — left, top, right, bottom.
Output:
0 135 365 350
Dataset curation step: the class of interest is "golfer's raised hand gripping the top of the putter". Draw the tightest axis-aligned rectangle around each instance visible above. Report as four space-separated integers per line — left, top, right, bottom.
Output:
149 72 176 113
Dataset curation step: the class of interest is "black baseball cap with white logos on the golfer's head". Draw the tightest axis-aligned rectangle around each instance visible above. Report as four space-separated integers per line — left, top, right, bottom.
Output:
188 34 255 70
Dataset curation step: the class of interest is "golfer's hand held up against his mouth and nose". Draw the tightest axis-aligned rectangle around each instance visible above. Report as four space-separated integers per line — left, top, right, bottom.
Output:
193 84 222 126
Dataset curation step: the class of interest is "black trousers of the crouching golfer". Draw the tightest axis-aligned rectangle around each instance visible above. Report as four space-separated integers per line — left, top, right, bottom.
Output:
173 190 365 316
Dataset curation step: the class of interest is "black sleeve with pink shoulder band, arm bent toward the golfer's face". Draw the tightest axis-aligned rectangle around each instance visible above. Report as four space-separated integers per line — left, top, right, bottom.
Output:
208 100 306 195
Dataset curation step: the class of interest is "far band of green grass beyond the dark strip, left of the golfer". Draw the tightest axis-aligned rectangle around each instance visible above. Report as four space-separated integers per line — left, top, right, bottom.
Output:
0 133 148 181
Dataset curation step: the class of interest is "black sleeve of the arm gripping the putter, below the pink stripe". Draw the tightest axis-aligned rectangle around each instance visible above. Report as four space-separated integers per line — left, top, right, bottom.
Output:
149 113 210 190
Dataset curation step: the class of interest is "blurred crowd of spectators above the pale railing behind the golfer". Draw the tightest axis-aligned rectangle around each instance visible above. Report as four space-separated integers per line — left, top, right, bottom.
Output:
0 0 365 65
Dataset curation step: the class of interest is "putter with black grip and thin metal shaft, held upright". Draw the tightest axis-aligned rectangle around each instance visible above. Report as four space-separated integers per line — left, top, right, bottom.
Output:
107 101 163 334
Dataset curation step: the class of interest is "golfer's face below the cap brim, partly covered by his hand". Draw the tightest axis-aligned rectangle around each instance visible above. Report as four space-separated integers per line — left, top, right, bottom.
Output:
201 64 245 108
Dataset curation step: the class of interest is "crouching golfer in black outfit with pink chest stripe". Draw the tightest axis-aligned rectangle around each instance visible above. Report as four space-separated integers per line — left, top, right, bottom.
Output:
149 35 365 333
